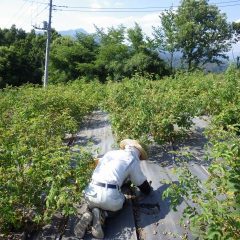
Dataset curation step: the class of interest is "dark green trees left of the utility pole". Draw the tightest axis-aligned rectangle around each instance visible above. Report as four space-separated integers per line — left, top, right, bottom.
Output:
0 26 46 88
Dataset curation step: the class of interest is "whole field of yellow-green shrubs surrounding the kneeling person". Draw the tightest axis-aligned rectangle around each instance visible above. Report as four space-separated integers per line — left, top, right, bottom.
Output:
0 67 240 239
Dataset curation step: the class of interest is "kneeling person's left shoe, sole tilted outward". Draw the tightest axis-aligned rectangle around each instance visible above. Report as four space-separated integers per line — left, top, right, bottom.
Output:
74 212 93 238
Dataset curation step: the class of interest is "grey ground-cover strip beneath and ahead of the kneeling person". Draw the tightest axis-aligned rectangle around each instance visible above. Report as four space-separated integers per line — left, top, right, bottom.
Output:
62 111 137 240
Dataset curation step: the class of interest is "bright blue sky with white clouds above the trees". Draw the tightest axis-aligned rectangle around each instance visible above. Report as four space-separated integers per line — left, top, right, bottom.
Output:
0 0 240 55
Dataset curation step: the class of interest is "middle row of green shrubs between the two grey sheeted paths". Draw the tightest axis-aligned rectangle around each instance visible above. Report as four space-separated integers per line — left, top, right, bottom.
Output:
105 71 208 143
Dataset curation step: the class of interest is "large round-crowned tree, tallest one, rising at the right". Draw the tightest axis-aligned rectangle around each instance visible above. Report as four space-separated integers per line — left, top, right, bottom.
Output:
174 0 232 70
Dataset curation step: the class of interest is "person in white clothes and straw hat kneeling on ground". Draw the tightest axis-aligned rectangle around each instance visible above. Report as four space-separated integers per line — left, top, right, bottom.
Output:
75 139 152 239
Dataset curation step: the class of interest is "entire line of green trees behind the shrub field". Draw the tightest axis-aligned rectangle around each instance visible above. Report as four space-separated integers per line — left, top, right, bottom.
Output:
0 0 240 88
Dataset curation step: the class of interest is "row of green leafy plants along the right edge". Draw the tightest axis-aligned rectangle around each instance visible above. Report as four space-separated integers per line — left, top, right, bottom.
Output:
164 68 240 240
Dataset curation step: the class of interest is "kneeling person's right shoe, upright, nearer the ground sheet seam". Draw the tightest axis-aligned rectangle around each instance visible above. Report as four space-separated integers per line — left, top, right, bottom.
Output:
92 208 105 239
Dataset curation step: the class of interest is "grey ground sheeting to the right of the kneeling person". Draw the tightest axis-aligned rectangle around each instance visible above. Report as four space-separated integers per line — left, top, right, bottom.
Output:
136 118 208 240
